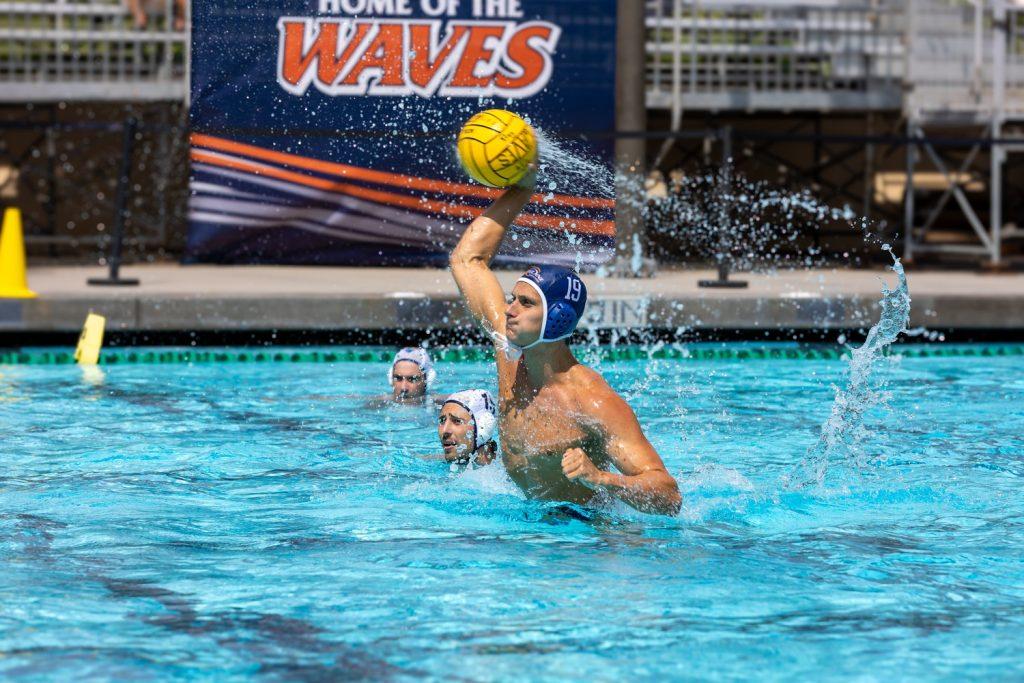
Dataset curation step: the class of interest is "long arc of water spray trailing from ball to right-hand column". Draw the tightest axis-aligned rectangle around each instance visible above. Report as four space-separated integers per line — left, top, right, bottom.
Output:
483 130 910 497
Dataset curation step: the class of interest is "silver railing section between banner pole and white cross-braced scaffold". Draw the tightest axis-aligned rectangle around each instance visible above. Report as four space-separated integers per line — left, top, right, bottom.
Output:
646 0 904 111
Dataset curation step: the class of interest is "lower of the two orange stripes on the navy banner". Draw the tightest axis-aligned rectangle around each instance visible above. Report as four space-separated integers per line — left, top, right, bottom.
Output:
190 150 615 237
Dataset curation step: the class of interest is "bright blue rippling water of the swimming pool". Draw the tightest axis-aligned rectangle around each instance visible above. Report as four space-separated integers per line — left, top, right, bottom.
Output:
0 346 1024 680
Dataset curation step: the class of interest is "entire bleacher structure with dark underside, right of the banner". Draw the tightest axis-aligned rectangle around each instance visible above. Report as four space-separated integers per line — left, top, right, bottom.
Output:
646 0 1024 265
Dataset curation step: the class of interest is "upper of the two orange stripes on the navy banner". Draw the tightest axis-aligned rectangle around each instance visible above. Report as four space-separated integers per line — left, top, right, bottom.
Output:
191 133 615 209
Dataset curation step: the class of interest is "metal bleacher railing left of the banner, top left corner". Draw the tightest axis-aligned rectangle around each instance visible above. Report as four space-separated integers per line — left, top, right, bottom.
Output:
0 0 189 102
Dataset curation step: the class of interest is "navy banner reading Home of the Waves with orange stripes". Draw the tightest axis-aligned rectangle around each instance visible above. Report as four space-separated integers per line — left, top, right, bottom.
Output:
186 0 615 265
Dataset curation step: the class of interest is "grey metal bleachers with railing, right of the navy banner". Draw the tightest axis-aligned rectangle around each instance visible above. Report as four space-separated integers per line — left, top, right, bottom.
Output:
646 0 1024 117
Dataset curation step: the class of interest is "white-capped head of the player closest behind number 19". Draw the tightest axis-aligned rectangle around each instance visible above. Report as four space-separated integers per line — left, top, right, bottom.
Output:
437 389 498 465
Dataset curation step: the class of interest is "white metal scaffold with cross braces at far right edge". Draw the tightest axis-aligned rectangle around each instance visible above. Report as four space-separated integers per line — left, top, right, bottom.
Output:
903 0 1024 266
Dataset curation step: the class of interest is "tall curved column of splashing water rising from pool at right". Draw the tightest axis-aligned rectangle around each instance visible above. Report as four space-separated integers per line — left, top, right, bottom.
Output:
784 245 910 488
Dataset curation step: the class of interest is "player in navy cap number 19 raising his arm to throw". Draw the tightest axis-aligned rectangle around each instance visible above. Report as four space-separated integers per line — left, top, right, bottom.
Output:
451 176 681 514
